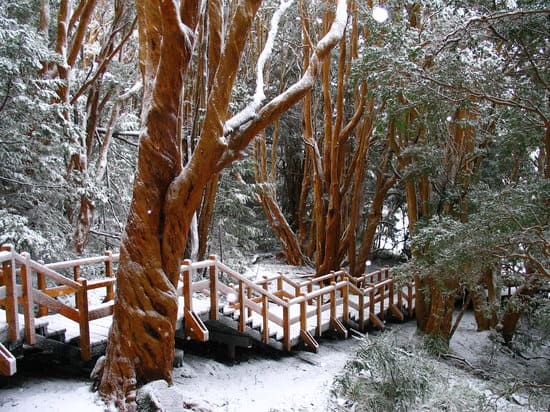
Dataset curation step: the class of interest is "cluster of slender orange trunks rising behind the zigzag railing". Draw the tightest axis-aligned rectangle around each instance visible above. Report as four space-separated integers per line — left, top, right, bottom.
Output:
255 1 404 275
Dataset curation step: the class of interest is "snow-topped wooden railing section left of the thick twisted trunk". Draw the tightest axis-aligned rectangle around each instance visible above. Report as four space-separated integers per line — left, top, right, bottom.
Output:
0 245 118 361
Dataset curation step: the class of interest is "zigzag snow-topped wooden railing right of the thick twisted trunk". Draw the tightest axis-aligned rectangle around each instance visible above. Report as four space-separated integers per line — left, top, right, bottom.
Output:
178 256 414 351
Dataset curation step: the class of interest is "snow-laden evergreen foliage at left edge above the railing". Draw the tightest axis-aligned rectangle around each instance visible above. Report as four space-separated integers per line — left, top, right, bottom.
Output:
0 3 71 258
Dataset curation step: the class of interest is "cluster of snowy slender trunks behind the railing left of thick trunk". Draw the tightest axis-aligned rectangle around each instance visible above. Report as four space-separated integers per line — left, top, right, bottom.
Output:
39 0 138 254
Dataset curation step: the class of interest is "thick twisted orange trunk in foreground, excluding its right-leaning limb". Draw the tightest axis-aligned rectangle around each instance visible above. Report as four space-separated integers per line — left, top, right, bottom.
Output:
99 0 192 410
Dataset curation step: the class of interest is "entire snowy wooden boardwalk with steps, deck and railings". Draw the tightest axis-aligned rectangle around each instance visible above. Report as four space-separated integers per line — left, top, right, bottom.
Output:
0 246 415 375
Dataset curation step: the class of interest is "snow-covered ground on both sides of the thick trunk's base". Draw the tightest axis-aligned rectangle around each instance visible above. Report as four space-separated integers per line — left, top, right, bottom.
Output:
0 339 364 412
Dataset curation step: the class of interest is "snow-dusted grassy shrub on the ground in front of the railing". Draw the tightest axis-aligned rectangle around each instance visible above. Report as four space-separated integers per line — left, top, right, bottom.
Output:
333 332 488 411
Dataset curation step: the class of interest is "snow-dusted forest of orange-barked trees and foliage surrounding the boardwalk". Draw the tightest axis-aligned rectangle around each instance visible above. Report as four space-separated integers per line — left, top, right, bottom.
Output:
0 0 550 410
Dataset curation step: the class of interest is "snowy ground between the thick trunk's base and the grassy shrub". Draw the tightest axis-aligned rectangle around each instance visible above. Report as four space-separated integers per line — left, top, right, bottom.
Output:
170 339 364 412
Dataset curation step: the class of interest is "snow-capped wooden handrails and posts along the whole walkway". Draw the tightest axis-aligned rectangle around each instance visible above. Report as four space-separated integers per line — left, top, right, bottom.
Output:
0 248 415 360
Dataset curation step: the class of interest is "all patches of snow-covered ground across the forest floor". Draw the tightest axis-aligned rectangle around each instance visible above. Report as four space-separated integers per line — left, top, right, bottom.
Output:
0 262 548 412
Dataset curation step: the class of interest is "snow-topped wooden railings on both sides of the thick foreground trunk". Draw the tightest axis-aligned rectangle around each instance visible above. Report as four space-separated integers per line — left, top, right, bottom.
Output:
0 246 415 372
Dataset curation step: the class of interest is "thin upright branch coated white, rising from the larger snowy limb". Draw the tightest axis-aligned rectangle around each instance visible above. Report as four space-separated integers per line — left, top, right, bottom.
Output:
223 0 294 135
